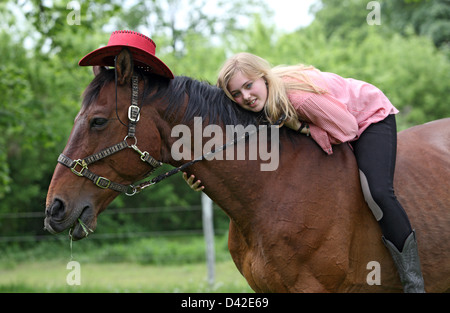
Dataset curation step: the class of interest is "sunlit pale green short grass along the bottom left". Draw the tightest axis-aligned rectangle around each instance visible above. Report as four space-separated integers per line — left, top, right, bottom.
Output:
0 261 252 293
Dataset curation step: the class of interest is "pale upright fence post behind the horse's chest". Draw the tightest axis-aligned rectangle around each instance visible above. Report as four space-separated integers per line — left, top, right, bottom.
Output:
202 192 215 288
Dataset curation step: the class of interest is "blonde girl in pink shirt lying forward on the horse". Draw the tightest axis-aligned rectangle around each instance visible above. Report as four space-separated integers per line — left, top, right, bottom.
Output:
183 53 424 292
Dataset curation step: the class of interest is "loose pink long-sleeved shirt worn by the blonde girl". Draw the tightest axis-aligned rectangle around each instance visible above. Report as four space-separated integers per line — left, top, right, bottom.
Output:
286 70 398 154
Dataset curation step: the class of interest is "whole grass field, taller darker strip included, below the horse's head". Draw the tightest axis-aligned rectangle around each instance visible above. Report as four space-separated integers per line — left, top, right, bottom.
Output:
0 237 253 293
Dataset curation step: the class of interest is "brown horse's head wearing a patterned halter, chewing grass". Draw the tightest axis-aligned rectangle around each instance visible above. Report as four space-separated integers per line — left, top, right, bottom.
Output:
44 49 170 240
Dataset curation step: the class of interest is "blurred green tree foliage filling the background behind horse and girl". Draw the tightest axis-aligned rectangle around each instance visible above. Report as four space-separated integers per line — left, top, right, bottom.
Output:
0 0 450 236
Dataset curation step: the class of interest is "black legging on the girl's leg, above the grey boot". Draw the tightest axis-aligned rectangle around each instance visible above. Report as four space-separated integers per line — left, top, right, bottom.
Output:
351 114 412 251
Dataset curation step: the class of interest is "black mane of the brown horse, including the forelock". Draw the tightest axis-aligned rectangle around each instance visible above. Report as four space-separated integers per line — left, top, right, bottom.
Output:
83 69 260 126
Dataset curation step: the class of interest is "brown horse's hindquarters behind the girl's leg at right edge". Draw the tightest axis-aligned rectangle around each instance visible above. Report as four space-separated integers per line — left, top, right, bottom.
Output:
394 118 450 292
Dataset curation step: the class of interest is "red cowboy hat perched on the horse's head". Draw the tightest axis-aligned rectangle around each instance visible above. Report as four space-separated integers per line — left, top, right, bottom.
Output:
78 30 173 78
